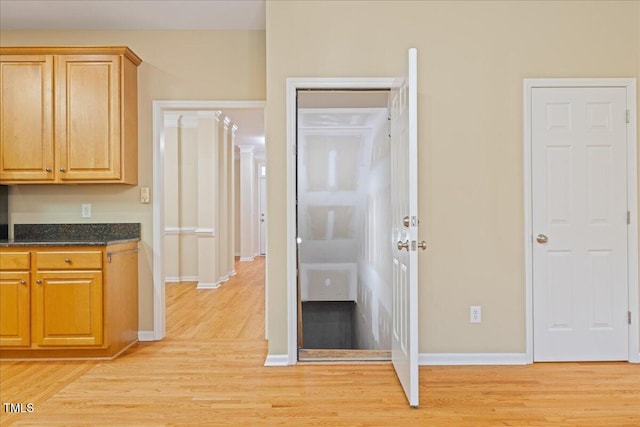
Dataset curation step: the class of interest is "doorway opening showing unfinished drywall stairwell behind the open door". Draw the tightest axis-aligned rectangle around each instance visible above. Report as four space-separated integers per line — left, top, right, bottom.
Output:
296 89 392 361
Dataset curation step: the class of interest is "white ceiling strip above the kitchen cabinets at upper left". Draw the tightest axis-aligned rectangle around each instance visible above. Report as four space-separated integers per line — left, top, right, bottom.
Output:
0 0 265 30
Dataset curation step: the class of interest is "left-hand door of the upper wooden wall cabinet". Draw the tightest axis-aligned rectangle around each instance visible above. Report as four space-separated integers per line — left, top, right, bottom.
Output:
0 55 54 181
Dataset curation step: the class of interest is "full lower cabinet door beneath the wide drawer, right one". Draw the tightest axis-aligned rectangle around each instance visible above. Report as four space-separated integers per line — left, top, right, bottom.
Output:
32 271 103 347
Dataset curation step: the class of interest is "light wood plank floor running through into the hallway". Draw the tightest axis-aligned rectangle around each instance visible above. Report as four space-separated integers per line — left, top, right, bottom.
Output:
0 258 640 427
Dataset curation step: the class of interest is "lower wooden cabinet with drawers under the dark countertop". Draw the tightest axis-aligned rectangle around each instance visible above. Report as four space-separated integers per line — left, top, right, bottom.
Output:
0 242 138 358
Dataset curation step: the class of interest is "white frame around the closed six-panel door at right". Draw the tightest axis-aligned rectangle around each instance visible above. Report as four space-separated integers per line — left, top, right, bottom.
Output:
523 78 640 363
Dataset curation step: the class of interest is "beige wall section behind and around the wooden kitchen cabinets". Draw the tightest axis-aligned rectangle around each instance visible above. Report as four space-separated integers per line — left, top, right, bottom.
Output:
0 31 265 330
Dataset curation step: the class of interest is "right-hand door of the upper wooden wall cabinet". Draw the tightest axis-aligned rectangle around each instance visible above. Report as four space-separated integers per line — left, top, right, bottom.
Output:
55 55 122 181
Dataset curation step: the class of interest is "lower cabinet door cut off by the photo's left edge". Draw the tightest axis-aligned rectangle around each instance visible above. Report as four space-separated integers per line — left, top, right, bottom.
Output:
0 271 31 347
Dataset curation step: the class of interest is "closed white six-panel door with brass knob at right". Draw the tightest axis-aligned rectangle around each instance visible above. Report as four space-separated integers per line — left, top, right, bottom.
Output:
531 87 629 361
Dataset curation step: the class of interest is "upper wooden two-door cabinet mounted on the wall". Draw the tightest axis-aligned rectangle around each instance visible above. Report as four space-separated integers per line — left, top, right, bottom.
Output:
0 47 142 185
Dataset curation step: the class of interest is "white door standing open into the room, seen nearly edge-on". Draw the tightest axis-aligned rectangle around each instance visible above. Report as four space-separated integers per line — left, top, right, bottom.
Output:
389 49 424 407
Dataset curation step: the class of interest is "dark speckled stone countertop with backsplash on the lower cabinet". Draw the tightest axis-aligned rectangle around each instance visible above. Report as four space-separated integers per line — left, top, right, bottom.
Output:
0 223 140 248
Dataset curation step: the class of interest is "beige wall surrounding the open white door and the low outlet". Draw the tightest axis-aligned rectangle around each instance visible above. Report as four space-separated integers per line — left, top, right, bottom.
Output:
266 1 640 354
